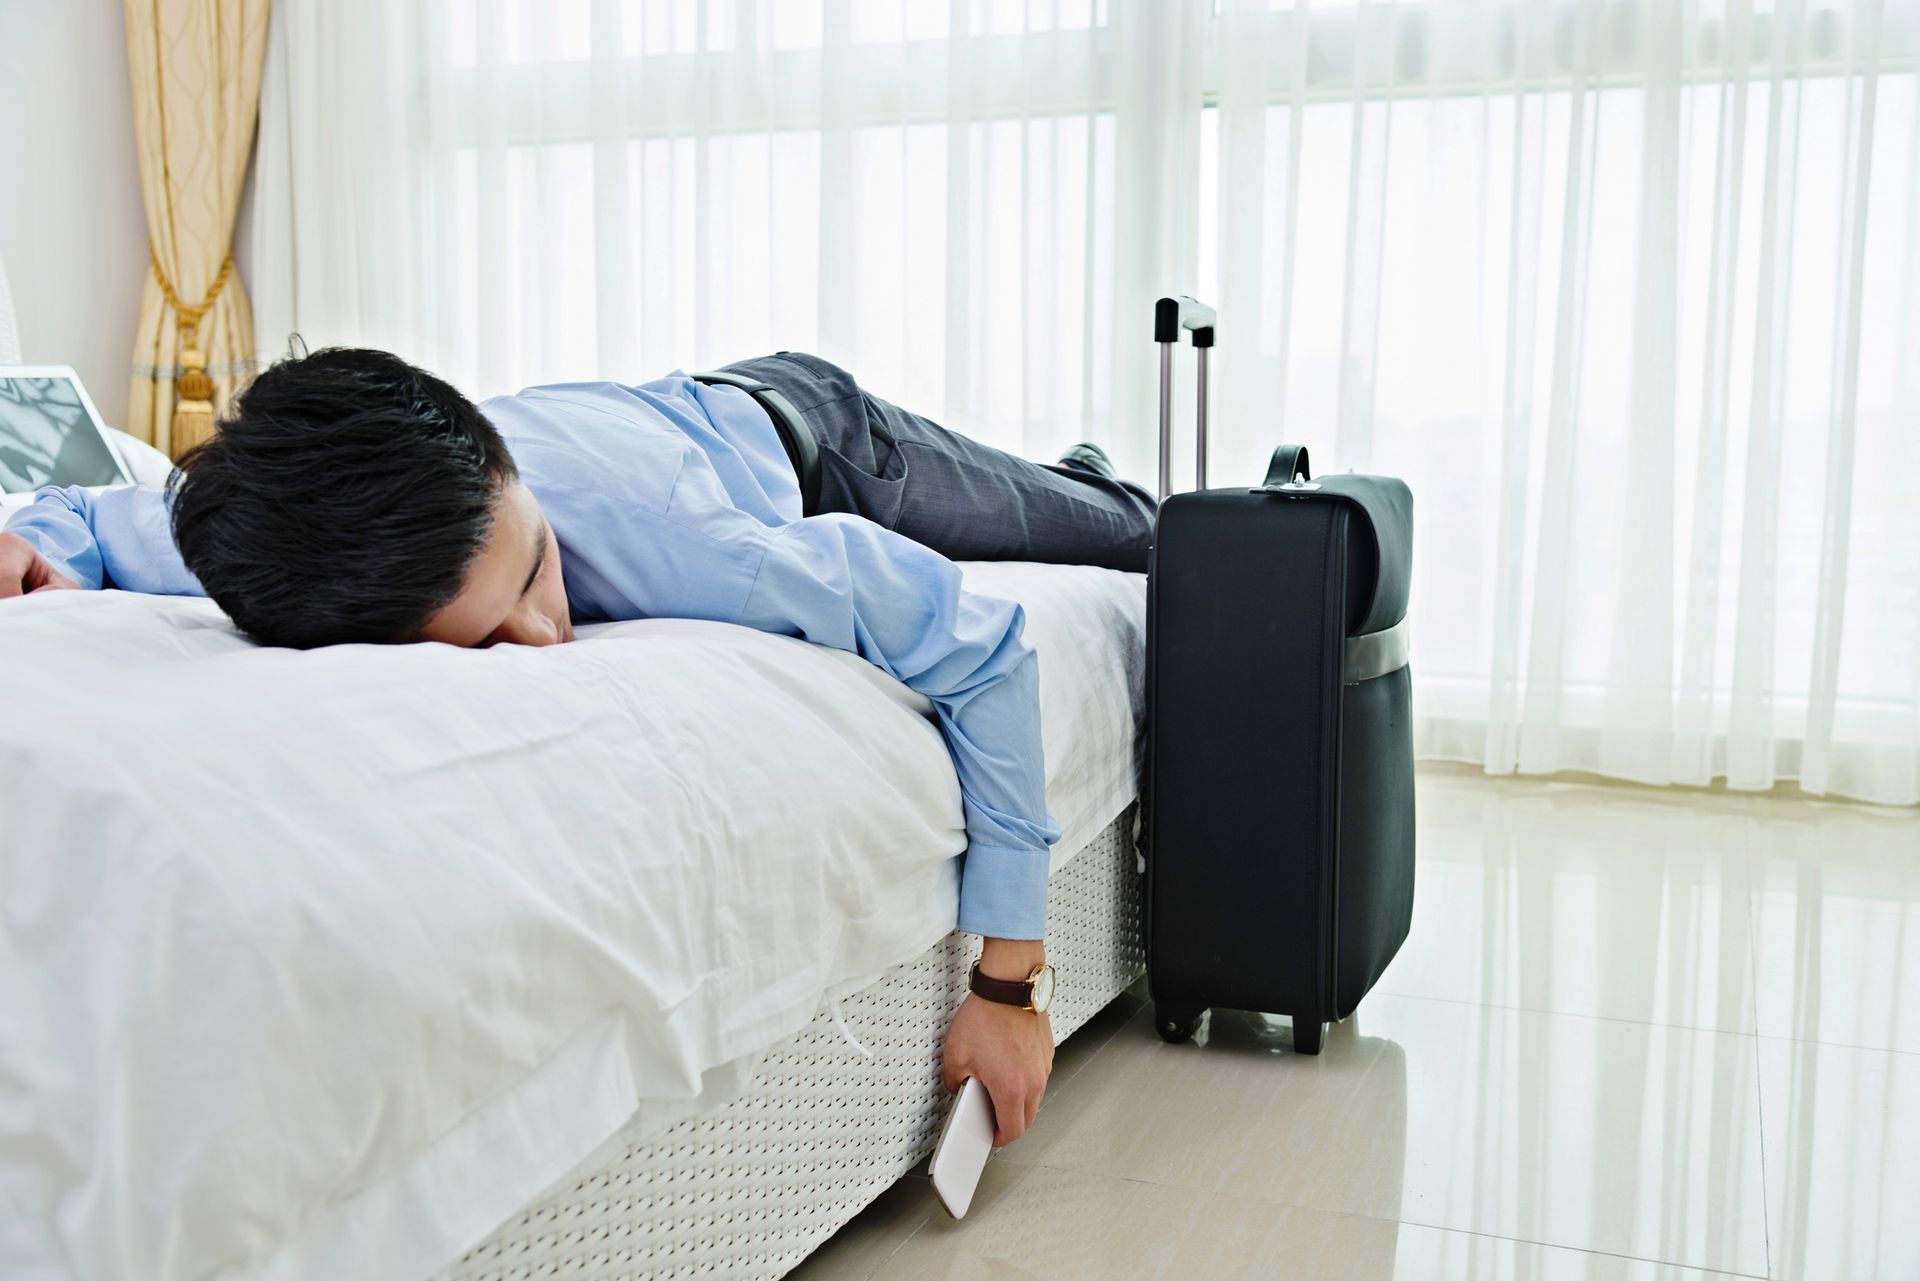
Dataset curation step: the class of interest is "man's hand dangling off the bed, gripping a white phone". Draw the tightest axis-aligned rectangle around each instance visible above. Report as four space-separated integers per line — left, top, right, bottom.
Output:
941 939 1054 1148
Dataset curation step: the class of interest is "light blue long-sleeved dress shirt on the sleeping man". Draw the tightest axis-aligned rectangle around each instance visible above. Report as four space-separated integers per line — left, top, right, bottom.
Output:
6 371 1060 939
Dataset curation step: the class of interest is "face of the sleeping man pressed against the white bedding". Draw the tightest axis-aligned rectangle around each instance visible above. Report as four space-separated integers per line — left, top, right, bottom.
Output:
420 480 574 649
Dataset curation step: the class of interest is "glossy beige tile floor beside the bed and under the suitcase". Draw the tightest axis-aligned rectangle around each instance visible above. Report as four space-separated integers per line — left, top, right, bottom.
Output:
791 772 1920 1281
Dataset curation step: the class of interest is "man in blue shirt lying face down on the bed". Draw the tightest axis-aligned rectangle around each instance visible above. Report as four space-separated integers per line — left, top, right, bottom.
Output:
0 350 1154 1147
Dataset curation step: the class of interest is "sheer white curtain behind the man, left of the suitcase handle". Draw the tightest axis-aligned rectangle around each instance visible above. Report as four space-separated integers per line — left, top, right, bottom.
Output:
255 0 1200 474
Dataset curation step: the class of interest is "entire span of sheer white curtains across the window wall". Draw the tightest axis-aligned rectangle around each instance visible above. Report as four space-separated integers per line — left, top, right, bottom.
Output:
255 0 1920 803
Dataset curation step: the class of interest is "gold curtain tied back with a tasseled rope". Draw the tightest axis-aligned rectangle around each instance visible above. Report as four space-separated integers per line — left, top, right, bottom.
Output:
125 0 269 457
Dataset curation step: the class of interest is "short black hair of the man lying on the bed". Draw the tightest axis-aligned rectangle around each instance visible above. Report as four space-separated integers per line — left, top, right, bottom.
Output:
167 348 518 649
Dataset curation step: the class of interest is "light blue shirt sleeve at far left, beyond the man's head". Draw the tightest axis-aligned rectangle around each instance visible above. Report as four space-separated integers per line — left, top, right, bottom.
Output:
6 486 205 595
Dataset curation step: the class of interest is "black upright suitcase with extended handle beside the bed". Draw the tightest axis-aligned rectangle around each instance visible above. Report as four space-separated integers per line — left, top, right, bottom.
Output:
1144 298 1413 1054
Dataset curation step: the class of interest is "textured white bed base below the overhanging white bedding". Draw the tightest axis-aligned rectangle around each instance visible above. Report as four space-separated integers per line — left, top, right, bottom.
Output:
438 807 1146 1281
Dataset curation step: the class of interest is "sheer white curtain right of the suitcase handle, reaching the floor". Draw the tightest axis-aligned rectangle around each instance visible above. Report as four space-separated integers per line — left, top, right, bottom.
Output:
1204 0 1920 803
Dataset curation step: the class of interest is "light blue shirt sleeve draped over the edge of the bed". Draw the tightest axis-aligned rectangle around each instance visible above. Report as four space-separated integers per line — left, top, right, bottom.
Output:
741 515 1060 939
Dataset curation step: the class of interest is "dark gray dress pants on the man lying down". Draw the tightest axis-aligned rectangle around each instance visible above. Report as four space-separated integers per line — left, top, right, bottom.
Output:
710 351 1158 570
